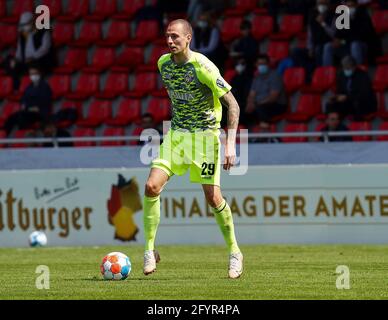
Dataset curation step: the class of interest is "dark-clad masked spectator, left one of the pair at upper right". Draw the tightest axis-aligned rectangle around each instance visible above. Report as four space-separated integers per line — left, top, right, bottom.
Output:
307 0 336 66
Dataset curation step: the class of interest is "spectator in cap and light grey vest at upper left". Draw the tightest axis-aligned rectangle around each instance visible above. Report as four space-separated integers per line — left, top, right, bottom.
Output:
6 12 55 90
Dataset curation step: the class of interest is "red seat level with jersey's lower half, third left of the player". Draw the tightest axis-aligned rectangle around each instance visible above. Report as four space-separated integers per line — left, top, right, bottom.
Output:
77 100 112 128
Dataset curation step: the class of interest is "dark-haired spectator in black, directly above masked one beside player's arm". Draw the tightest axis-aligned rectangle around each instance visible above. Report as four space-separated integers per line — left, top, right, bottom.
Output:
230 20 259 68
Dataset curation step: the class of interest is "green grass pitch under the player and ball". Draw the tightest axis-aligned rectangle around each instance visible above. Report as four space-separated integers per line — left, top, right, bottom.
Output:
0 245 388 300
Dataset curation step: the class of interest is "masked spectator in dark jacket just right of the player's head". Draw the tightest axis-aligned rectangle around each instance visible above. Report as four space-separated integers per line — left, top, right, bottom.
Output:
191 13 226 72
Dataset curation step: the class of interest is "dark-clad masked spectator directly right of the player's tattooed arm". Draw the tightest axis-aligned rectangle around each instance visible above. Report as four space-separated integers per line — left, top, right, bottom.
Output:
230 58 253 125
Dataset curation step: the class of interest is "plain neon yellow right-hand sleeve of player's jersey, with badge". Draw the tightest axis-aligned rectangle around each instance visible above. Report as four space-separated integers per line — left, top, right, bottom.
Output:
199 57 232 98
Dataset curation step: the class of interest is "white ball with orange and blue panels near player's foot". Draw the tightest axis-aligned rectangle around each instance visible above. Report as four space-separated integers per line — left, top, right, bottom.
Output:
100 252 131 280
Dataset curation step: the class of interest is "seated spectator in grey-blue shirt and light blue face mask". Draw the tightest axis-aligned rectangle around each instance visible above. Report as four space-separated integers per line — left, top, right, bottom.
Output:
246 55 287 122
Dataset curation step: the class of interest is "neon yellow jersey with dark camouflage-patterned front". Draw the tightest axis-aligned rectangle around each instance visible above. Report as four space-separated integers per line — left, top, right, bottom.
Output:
158 52 231 132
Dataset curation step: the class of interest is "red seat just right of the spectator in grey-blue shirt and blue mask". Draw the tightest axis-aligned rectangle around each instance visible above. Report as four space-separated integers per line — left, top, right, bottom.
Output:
286 94 321 122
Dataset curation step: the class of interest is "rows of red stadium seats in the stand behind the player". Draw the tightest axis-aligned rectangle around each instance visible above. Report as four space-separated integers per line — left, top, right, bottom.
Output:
0 0 388 148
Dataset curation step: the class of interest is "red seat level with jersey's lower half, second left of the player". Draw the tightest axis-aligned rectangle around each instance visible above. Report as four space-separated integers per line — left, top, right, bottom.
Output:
105 99 141 126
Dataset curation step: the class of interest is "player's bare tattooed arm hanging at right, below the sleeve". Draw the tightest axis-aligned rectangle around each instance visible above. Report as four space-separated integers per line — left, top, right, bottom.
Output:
220 91 240 170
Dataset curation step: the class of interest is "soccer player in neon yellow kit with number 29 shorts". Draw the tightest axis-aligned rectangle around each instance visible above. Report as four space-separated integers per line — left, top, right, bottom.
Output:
143 19 243 279
